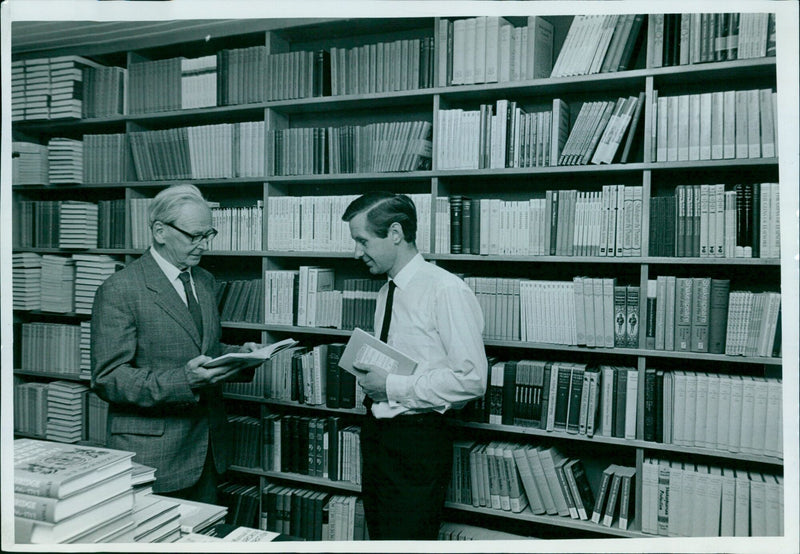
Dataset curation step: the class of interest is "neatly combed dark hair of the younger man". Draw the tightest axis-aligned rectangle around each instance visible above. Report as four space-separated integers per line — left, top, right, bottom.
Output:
342 191 417 243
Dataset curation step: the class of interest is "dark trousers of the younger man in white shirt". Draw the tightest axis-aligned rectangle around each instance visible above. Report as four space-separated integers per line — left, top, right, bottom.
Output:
361 413 453 540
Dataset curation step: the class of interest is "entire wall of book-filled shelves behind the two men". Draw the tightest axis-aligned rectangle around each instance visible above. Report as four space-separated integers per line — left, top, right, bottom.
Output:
11 10 785 542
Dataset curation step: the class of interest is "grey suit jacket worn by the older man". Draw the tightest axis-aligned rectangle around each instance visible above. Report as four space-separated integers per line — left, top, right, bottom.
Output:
91 250 237 492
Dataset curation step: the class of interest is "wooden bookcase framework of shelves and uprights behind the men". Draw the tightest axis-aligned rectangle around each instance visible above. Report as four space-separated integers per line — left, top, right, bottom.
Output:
13 10 783 537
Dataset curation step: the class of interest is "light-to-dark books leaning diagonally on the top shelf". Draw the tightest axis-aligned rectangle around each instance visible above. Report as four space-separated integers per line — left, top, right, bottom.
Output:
550 14 645 77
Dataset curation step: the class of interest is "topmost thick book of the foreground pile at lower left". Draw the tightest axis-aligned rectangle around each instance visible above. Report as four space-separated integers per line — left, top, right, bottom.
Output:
14 439 134 498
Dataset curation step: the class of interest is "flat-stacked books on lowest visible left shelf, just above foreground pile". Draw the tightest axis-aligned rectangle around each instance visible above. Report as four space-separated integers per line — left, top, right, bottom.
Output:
47 381 89 443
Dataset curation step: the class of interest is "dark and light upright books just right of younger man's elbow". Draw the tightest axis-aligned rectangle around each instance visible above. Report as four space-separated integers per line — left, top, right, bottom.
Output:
478 358 639 439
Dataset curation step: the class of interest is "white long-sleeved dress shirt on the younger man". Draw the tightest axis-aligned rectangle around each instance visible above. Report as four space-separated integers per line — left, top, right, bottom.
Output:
372 254 488 418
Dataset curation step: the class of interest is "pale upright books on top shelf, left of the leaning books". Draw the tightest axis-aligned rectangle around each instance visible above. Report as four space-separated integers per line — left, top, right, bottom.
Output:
436 16 553 87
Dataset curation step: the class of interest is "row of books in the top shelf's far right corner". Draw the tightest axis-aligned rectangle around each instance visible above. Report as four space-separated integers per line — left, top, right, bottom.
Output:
647 13 775 67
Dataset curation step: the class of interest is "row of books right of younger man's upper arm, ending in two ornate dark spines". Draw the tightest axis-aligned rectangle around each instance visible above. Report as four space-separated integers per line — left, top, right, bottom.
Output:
464 277 639 348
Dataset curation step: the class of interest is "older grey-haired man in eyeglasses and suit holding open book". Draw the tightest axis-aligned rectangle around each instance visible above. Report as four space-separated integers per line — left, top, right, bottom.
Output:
91 185 260 503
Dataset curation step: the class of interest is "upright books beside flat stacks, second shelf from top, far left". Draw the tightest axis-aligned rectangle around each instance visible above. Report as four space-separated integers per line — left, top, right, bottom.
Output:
83 133 136 183
